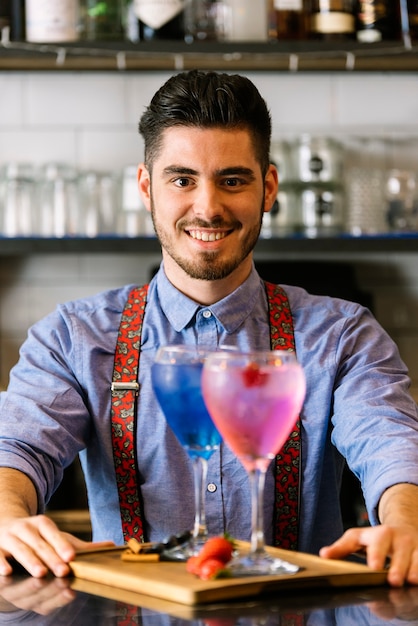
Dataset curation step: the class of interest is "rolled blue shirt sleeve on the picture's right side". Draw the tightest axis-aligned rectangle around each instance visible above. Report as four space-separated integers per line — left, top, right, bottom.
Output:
332 303 418 524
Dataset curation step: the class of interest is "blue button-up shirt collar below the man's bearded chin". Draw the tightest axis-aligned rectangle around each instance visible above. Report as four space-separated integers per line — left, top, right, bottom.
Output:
156 264 261 333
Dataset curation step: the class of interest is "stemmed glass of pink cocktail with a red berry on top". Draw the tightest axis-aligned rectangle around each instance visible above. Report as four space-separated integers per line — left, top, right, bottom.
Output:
202 350 305 576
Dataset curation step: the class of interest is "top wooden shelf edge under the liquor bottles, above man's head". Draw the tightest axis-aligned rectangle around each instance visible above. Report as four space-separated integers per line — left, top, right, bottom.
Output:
0 37 418 72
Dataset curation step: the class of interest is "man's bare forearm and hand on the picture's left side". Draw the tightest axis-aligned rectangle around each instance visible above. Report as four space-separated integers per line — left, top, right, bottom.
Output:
0 467 108 578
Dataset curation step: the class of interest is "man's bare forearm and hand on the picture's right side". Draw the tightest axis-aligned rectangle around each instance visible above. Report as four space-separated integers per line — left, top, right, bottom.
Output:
320 483 418 587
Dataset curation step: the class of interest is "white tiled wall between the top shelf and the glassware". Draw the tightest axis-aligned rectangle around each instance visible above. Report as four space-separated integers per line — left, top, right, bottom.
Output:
0 71 418 169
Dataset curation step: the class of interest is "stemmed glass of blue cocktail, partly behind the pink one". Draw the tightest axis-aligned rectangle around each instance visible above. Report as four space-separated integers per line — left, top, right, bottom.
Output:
151 345 221 560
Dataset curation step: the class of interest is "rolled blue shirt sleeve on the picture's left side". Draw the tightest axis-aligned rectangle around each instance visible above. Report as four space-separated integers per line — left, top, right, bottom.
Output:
0 310 93 511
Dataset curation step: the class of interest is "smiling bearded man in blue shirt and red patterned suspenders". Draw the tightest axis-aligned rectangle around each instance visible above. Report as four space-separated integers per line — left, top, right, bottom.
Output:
0 71 418 586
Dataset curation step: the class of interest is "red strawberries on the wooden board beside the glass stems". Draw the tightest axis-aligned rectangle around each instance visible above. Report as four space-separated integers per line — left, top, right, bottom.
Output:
186 535 234 580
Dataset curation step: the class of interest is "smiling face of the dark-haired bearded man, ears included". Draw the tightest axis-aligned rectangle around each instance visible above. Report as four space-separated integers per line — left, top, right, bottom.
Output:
139 126 277 280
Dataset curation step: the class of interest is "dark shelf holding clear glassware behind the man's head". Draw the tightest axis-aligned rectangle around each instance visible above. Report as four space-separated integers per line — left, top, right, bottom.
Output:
0 233 418 257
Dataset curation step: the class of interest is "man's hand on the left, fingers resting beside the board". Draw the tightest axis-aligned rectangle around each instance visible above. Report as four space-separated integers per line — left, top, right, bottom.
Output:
0 515 113 578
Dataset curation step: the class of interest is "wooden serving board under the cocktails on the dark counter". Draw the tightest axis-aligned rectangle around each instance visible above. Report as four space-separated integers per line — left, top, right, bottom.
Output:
70 548 386 605
